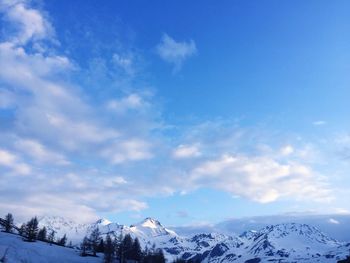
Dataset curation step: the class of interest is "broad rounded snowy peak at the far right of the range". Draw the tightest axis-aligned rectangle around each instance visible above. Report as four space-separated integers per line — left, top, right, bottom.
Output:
242 223 346 262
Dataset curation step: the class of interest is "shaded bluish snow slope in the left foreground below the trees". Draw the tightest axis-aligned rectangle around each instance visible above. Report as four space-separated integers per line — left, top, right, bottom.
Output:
0 232 102 263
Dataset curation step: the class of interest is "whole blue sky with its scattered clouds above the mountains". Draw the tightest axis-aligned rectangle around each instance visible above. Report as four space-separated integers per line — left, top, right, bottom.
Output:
0 0 350 226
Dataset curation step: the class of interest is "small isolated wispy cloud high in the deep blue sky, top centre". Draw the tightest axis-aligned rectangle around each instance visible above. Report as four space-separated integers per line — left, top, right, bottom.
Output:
156 34 197 72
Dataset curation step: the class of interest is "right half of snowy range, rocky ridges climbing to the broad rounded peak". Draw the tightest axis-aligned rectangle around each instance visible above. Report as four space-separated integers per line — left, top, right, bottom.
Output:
172 223 350 263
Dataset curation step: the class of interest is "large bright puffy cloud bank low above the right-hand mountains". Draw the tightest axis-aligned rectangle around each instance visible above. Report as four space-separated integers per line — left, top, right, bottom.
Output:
187 155 331 203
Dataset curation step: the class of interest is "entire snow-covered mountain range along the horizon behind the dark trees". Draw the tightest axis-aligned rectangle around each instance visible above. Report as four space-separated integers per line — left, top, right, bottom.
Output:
34 217 350 263
